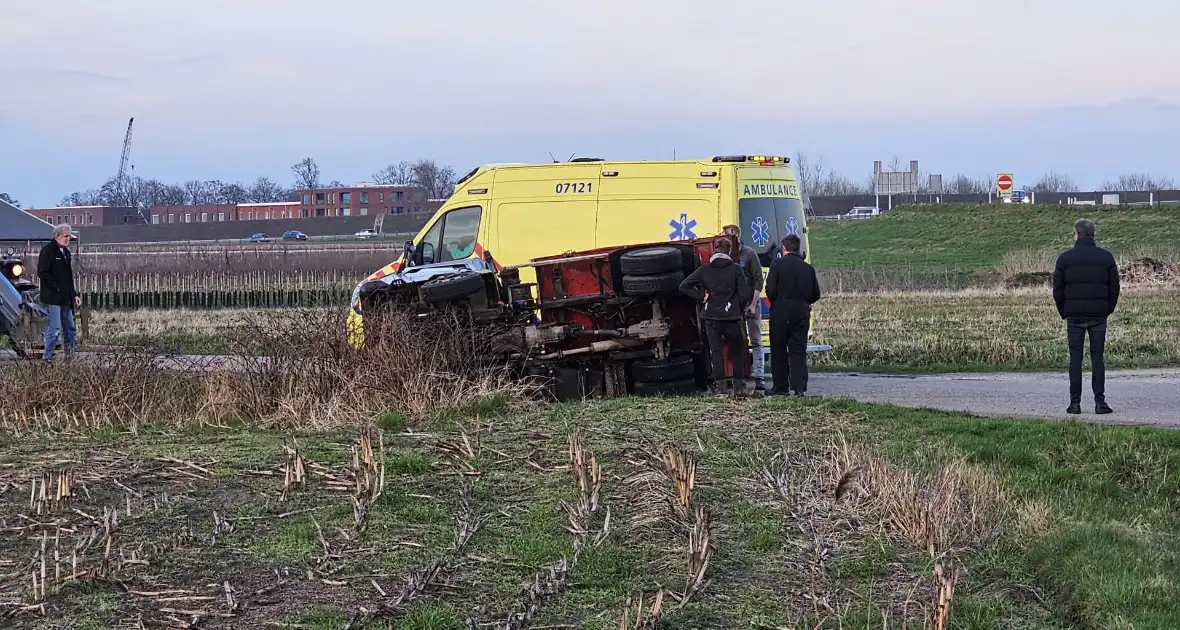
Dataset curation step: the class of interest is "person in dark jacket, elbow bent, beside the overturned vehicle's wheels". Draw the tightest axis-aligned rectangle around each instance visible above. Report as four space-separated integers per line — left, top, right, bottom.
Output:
680 238 753 389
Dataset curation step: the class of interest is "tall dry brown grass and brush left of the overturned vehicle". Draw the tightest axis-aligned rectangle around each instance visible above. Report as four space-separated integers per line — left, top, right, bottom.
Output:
0 310 522 433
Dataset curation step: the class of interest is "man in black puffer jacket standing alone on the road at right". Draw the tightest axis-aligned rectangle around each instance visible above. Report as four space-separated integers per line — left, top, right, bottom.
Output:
1053 218 1119 414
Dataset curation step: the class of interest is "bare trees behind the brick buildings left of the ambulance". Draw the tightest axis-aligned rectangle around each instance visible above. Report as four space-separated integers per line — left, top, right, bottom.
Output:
55 157 458 212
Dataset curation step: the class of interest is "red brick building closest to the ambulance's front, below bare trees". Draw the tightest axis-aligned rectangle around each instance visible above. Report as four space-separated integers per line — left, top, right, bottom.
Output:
299 182 438 218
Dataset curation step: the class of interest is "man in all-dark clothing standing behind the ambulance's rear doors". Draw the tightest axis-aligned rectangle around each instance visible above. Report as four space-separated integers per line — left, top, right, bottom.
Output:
766 234 819 396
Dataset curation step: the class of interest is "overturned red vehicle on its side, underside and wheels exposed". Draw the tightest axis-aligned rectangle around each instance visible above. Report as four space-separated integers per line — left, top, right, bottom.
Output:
360 238 749 400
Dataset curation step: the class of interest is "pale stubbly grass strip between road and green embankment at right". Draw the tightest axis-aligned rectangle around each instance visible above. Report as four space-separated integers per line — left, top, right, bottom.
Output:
812 289 1180 373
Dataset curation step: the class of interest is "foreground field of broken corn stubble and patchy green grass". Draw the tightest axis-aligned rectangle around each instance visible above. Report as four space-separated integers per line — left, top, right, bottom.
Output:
0 399 1180 630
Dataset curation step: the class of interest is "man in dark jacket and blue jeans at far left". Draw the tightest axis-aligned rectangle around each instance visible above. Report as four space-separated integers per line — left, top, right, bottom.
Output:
37 223 81 361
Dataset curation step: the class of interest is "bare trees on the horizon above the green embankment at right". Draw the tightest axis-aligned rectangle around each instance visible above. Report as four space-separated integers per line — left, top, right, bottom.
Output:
792 153 1176 197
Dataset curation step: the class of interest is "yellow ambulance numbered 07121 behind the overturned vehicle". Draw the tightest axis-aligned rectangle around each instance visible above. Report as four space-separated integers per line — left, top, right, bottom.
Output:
348 156 814 350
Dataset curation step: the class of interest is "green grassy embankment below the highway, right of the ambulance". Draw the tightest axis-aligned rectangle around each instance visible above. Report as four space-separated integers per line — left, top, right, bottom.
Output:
808 204 1180 272
